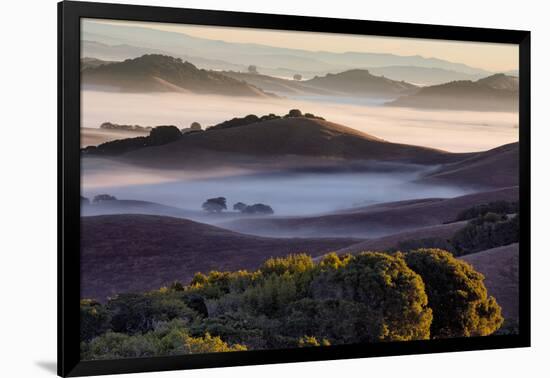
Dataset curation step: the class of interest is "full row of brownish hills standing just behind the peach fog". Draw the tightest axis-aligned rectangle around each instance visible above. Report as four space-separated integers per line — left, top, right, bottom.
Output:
81 54 519 112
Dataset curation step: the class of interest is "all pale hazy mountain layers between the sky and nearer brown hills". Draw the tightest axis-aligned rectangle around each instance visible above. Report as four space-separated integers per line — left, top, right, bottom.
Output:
82 22 504 85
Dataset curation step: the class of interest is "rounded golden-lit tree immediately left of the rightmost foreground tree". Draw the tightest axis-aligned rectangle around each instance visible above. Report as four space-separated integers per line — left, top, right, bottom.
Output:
311 252 432 341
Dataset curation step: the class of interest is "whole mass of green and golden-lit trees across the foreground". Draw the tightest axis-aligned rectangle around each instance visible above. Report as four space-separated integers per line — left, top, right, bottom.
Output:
81 249 502 359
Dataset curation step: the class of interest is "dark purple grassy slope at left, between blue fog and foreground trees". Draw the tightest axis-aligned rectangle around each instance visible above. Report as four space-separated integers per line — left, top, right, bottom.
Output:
80 214 358 300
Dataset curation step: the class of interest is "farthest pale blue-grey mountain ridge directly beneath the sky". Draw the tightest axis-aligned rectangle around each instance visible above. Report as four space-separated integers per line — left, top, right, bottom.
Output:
82 21 498 77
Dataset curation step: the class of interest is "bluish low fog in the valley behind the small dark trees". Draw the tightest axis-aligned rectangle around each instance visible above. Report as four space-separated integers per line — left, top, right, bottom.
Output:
82 159 474 222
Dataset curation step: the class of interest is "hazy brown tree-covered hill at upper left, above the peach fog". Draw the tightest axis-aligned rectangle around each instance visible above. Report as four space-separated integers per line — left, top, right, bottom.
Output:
81 54 271 97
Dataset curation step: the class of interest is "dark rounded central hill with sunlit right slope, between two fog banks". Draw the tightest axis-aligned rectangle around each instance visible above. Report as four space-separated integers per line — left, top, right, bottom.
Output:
84 113 470 167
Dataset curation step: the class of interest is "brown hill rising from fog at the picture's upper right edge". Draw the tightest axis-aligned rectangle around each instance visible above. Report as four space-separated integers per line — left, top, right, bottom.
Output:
386 74 519 112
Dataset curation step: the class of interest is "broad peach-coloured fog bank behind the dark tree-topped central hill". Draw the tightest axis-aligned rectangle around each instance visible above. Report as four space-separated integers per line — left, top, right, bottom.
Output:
81 90 518 152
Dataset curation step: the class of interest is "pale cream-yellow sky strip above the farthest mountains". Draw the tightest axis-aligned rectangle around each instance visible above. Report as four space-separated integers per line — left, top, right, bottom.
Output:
88 20 519 72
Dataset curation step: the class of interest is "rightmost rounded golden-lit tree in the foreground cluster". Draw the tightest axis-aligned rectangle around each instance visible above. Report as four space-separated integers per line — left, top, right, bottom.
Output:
405 249 503 338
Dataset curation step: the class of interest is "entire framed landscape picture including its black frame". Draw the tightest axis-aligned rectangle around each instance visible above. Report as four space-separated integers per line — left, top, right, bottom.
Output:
58 2 530 376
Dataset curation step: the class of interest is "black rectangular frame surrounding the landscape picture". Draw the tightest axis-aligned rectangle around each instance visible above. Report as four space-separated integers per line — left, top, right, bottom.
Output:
58 1 531 377
